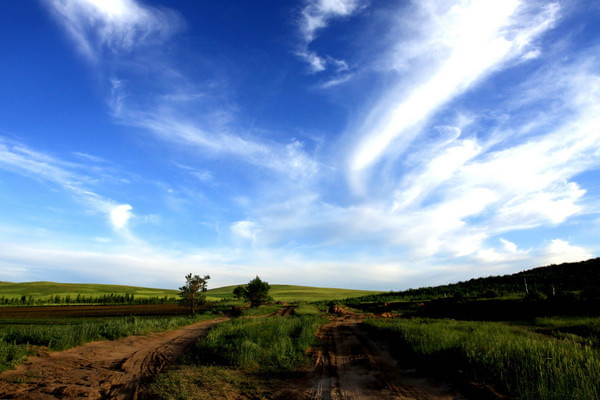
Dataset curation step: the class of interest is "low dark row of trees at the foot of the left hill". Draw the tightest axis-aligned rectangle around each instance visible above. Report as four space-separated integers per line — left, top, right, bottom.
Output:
0 293 177 306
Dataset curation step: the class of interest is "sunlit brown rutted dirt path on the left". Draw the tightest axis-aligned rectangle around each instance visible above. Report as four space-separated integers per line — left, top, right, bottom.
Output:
0 318 228 400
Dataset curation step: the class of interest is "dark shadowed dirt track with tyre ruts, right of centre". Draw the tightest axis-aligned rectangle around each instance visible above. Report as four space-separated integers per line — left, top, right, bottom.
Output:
304 315 472 400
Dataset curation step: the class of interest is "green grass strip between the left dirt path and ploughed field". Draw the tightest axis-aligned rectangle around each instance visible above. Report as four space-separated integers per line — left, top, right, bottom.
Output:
0 314 214 371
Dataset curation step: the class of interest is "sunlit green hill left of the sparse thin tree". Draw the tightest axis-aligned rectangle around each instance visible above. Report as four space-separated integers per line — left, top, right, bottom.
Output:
0 282 179 299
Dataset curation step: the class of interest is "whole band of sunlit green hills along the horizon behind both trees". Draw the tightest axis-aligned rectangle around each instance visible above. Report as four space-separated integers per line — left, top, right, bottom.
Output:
0 282 381 301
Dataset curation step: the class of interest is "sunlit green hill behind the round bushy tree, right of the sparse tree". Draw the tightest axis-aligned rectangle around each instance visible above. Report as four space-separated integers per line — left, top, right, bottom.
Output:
206 285 381 302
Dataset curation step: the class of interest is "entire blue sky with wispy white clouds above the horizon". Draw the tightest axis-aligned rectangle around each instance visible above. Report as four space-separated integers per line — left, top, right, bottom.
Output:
0 0 600 290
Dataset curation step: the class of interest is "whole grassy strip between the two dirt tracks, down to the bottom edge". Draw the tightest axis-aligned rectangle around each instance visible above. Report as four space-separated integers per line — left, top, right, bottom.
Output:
142 314 327 400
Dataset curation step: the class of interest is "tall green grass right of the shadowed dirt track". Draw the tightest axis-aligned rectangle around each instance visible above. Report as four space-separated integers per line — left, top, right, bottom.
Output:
366 319 600 400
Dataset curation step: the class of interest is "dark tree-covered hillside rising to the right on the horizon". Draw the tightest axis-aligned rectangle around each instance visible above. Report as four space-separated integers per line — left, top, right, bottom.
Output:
345 258 600 304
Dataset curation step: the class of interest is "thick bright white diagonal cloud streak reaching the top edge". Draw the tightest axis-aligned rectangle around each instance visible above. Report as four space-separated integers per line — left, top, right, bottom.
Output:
350 0 558 184
